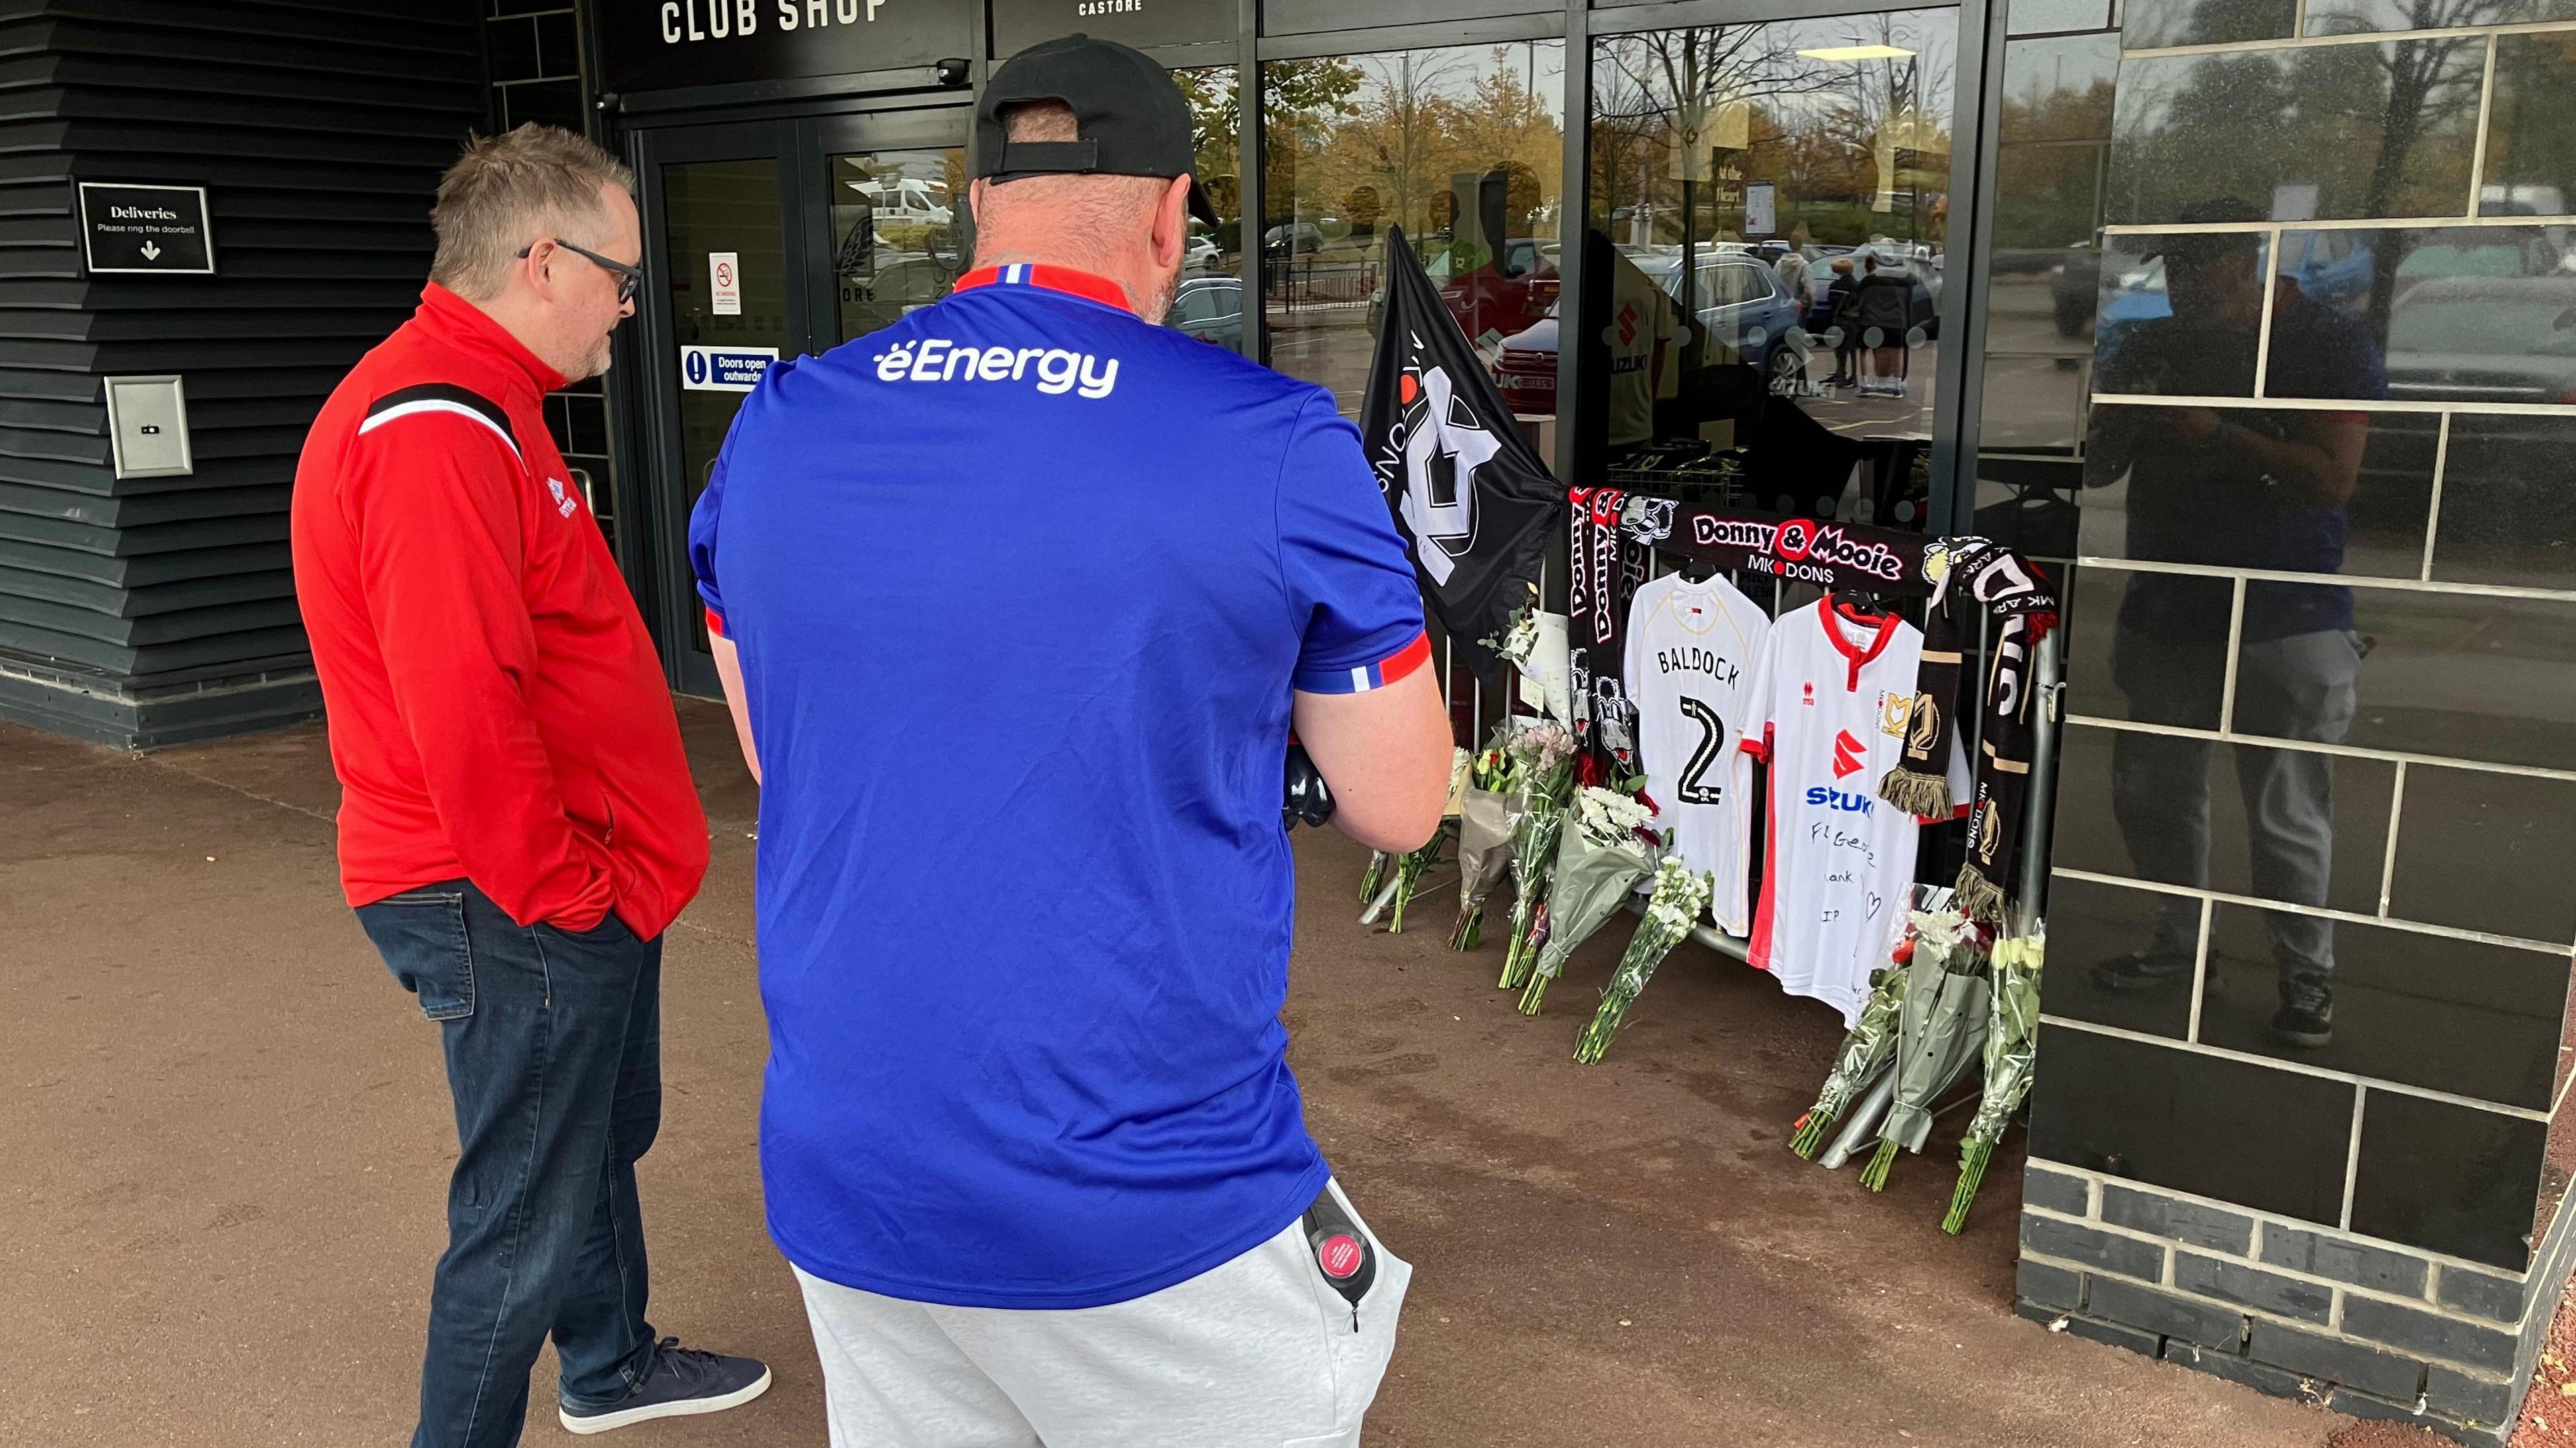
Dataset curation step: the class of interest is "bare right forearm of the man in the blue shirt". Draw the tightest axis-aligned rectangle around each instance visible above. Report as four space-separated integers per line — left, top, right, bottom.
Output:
1296 667 1453 855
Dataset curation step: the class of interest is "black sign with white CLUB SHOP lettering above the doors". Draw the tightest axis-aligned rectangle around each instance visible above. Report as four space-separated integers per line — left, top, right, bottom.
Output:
600 0 976 93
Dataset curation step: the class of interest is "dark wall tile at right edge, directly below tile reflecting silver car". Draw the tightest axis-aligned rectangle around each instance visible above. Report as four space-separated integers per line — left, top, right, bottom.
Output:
2432 412 2576 588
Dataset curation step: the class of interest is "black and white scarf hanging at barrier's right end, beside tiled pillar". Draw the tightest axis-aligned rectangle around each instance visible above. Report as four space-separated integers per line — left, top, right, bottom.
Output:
1878 539 2058 922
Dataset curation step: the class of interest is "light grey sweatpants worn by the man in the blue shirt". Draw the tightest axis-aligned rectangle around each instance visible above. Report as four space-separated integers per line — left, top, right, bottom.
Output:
796 1185 1414 1448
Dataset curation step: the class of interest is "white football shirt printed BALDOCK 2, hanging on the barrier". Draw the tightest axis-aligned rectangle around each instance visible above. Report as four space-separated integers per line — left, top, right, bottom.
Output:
1625 575 1770 936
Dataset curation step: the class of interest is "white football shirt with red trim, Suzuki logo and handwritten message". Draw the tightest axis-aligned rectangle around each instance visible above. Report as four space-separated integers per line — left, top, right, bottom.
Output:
1739 595 1968 1025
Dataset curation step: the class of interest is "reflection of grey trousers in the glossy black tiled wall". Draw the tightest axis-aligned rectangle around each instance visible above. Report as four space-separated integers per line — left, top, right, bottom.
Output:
2110 628 2362 985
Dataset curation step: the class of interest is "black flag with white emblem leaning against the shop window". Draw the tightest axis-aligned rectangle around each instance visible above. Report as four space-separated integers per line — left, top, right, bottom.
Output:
1360 227 1566 673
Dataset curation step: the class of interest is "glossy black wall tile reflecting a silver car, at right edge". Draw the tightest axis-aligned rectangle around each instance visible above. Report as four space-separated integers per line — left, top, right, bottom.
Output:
2264 227 2576 402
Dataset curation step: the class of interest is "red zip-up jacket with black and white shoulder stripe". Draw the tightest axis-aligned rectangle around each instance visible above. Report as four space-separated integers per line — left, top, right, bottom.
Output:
294 284 706 938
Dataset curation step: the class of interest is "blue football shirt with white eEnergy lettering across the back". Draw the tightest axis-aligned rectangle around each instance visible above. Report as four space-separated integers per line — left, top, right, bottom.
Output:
688 266 1430 1309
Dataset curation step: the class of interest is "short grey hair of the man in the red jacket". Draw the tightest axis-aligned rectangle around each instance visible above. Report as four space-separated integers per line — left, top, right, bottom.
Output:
430 121 636 301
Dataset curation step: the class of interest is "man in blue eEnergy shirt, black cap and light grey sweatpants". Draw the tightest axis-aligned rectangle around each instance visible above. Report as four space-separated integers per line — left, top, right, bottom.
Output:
690 36 1450 1448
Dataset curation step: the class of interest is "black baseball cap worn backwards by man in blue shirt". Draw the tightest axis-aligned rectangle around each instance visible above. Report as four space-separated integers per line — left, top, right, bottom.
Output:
974 36 1216 227
